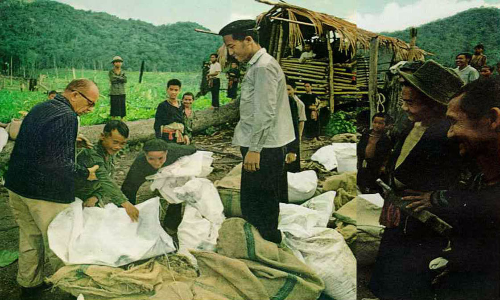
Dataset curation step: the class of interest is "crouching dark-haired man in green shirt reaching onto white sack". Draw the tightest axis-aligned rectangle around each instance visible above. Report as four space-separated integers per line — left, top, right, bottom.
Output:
75 120 139 221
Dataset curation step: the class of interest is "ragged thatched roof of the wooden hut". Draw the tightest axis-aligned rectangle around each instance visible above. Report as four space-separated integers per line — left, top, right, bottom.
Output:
255 0 431 60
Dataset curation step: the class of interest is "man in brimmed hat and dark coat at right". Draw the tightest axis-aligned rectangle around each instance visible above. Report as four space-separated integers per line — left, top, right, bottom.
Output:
369 60 463 299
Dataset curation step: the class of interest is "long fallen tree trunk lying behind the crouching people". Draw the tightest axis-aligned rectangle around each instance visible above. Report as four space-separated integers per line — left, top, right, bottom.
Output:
0 101 239 167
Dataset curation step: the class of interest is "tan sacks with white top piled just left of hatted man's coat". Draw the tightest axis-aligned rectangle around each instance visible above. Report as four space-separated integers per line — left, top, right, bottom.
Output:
336 194 384 265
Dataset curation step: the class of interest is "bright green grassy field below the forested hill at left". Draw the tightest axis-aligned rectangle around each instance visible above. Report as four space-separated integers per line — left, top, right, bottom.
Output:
0 70 231 125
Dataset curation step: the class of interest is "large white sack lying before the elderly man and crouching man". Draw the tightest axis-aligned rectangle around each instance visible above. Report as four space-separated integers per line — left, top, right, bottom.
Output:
48 197 175 267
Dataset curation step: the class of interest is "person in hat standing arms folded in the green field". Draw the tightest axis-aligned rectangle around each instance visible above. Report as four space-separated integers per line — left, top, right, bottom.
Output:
108 56 127 119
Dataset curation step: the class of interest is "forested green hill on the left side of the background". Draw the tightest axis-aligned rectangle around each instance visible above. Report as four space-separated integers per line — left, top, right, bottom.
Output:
0 0 222 71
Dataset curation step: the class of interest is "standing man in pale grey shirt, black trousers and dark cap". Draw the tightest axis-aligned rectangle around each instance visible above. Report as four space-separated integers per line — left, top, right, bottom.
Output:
219 20 295 243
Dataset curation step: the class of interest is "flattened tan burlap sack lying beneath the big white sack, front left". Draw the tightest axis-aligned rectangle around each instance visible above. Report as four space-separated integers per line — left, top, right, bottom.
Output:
47 255 197 300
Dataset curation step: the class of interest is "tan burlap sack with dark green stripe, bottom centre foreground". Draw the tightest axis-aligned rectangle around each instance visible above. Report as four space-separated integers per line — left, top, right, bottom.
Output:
193 218 324 300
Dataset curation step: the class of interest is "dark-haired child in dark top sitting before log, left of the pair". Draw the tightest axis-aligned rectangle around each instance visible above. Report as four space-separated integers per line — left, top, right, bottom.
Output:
154 79 190 145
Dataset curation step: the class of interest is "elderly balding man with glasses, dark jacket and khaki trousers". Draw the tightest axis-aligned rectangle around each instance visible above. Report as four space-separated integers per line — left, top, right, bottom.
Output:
5 79 99 294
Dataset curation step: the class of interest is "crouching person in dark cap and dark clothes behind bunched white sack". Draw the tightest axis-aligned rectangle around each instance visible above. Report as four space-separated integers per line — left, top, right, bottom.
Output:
122 139 196 234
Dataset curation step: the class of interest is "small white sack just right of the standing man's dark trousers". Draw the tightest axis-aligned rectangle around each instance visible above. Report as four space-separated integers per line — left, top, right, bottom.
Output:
287 170 318 203
